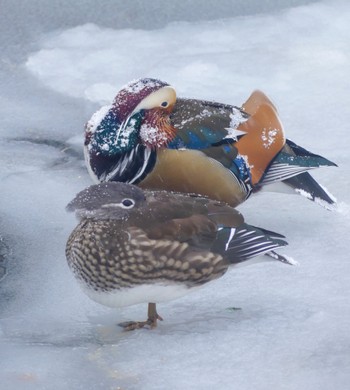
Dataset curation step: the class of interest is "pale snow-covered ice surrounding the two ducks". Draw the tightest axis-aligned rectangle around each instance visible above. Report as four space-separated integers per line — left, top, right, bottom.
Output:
0 0 350 390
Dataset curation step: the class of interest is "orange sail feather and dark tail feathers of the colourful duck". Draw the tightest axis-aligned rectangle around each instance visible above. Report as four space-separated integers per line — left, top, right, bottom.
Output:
235 91 337 208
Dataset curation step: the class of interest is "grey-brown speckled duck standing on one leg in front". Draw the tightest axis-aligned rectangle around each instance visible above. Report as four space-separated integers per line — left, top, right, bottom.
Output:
66 182 293 330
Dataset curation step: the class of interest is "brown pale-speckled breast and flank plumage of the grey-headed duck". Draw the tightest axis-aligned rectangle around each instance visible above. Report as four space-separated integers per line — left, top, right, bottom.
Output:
67 220 229 292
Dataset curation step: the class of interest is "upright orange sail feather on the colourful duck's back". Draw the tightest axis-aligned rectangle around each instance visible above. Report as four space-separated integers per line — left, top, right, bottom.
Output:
235 91 286 185
